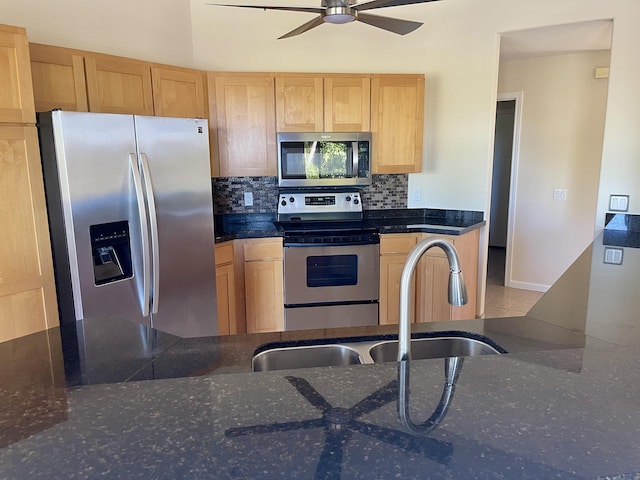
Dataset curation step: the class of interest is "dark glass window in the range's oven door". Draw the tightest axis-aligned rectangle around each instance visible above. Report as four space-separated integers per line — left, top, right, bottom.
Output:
307 255 358 287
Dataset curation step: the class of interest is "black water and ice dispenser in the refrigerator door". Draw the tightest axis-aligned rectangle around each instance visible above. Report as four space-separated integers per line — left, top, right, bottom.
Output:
89 221 133 285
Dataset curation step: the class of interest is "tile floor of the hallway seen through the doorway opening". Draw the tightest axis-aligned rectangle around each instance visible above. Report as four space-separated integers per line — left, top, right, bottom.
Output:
484 247 543 318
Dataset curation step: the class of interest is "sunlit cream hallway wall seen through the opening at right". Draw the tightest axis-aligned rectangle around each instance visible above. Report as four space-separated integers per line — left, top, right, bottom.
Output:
498 51 609 290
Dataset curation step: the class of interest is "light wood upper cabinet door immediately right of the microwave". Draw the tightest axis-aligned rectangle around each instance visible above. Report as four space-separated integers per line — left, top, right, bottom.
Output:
371 75 424 173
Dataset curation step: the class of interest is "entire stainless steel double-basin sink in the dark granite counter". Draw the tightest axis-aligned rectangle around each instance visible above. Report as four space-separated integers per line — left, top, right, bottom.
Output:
252 332 505 372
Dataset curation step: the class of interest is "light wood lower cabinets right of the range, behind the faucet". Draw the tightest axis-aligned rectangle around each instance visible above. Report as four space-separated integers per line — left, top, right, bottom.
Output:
380 230 479 325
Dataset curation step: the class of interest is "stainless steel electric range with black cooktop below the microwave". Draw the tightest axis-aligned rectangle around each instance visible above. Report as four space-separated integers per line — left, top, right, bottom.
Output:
277 190 380 330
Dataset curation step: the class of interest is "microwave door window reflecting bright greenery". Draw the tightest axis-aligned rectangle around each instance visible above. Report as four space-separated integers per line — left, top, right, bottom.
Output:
280 141 353 179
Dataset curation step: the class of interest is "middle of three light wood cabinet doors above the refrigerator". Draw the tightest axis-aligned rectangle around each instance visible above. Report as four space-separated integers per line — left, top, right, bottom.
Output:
84 55 153 115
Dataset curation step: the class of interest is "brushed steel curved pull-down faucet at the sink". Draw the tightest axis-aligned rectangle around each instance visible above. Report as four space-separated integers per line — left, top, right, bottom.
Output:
398 238 467 362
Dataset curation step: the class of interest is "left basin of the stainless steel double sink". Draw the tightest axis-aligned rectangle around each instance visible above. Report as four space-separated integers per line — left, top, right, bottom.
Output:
251 345 362 372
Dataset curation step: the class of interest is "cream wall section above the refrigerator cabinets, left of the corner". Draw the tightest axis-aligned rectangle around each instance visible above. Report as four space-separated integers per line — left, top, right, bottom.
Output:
0 0 193 67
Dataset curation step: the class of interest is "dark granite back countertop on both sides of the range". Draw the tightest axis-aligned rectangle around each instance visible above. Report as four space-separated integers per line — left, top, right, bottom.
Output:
214 208 486 243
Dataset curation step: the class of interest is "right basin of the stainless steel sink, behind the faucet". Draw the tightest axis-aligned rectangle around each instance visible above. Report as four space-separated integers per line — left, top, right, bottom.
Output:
369 337 501 363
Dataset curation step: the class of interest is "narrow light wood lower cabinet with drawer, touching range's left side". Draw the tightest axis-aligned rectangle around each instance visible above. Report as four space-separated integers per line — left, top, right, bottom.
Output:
243 238 284 333
